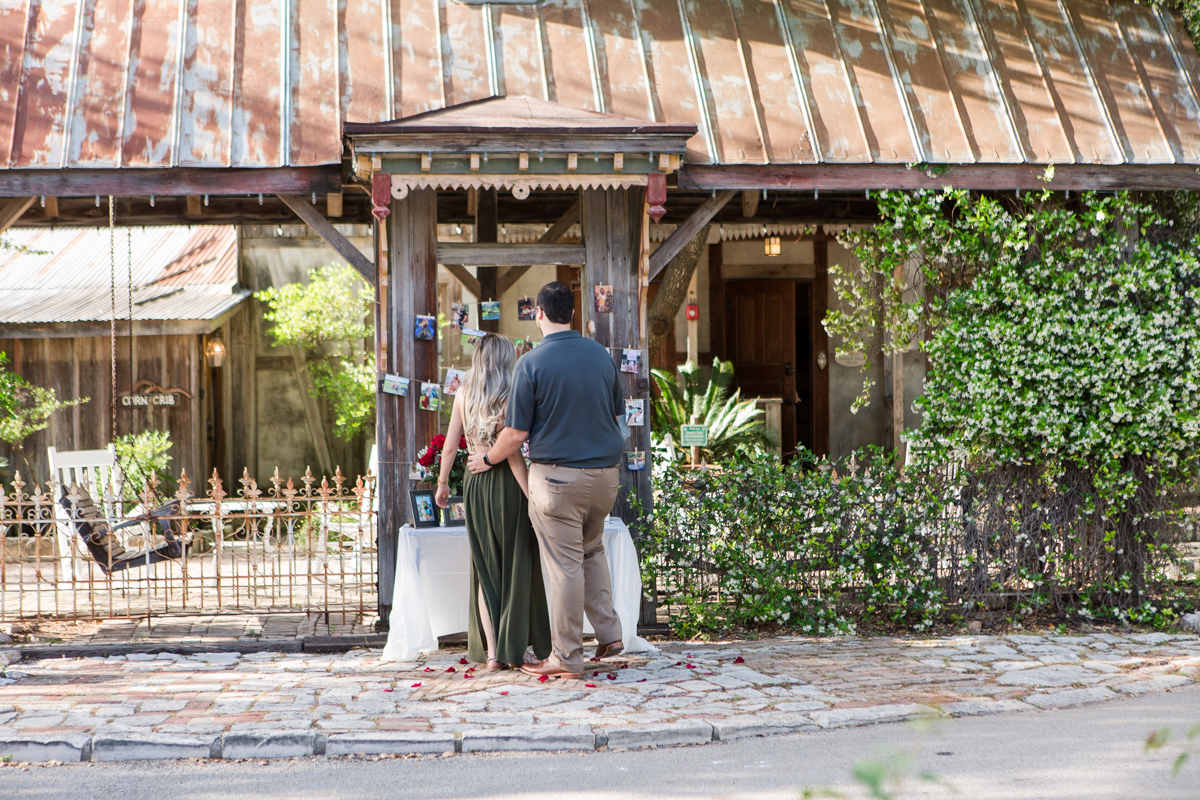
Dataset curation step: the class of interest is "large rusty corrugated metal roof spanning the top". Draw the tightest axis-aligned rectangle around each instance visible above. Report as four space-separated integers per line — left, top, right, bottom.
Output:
0 0 1200 168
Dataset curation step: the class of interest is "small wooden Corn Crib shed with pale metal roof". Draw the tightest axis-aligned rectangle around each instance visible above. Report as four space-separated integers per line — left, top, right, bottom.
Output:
0 225 250 489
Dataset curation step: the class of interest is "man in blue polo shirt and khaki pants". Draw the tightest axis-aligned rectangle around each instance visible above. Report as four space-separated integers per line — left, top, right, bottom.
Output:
467 281 625 678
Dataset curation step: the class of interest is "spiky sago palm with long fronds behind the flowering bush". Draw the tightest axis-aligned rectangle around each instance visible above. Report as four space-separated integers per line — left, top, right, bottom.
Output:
650 359 773 464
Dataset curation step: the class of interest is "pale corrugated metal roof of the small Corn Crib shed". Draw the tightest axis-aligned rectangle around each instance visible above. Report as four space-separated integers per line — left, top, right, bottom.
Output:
0 225 248 325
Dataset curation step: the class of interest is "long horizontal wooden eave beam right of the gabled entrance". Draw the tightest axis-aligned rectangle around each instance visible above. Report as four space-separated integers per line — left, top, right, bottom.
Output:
678 164 1200 192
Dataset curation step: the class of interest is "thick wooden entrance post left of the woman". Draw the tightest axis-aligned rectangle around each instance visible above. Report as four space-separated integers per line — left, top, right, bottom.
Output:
376 190 439 630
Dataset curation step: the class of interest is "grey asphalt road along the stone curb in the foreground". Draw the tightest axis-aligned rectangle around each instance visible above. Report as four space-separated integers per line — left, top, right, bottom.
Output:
0 686 1200 800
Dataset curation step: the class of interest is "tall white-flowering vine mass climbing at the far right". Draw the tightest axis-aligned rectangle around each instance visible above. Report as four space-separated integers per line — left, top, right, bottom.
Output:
827 191 1200 614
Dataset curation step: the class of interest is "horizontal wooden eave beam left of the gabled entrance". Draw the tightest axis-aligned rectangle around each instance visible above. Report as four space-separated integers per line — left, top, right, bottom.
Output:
0 164 342 198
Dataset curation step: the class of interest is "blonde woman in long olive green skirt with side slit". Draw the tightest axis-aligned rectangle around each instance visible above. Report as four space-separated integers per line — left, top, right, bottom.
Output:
436 333 551 669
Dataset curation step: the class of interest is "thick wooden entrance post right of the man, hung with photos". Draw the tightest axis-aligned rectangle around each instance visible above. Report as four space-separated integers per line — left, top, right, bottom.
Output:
582 188 656 624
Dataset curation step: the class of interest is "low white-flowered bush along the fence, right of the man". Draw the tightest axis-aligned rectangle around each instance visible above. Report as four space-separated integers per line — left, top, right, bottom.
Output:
642 451 947 636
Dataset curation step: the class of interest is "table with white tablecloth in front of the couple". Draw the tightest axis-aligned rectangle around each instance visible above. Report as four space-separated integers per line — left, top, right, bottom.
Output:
383 517 654 661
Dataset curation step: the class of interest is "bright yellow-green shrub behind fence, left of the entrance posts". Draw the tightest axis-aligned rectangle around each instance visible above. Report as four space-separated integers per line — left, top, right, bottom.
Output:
254 265 376 439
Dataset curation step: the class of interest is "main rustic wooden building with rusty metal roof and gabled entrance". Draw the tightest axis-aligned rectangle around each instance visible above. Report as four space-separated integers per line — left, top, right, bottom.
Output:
0 0 1200 623
